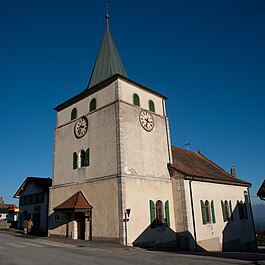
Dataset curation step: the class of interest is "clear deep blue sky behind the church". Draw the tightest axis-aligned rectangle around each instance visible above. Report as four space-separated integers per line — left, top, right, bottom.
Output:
0 0 265 203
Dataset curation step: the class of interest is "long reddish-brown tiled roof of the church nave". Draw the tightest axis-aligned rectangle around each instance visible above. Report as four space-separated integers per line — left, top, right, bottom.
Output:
169 146 251 186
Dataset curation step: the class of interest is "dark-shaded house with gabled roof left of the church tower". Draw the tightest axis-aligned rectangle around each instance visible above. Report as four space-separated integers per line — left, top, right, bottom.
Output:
14 177 52 235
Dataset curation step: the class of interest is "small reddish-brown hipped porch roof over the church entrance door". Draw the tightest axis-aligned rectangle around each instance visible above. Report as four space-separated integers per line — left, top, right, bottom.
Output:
53 191 93 212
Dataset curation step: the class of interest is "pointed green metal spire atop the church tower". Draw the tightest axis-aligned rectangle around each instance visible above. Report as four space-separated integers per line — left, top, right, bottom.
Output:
88 2 127 89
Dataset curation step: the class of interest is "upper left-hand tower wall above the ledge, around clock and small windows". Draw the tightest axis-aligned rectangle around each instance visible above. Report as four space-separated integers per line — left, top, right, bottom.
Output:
53 83 117 185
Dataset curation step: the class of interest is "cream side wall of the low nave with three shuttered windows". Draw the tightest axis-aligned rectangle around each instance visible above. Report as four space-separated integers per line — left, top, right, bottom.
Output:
185 180 254 251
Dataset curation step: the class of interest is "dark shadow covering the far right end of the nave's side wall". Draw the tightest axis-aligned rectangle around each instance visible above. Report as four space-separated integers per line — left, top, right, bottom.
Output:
222 201 257 251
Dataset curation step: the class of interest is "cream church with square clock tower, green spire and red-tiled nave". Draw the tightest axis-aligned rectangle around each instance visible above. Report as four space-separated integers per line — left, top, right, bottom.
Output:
49 5 256 251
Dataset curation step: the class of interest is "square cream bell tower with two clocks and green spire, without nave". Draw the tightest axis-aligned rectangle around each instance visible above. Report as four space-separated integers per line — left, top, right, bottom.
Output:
49 4 175 244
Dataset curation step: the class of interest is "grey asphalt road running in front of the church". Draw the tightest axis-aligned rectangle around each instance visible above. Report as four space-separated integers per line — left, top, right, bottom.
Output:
0 231 265 265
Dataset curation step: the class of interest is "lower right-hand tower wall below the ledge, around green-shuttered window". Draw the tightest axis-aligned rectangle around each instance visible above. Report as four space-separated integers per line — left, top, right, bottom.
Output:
125 176 175 245
